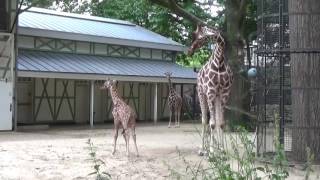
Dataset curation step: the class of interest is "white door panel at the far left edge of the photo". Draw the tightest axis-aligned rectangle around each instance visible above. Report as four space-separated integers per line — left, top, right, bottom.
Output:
0 33 14 130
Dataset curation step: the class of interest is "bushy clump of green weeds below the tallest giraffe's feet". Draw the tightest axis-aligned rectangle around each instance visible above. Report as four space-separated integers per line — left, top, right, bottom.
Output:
165 128 264 180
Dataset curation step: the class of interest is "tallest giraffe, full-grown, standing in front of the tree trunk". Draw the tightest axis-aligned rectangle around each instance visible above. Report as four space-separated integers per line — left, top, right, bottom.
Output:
188 25 233 155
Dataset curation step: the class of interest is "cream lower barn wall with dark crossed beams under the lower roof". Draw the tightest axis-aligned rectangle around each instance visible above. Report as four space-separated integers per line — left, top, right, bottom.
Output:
18 78 193 124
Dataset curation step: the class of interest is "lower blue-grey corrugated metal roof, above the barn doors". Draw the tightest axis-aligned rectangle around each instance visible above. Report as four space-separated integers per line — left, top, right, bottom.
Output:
18 51 196 80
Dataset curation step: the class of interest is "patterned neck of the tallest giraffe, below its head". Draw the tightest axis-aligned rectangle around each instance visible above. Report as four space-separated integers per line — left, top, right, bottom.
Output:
210 34 225 70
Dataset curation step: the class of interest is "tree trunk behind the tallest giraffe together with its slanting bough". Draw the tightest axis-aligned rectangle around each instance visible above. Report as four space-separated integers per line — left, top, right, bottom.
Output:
149 0 254 127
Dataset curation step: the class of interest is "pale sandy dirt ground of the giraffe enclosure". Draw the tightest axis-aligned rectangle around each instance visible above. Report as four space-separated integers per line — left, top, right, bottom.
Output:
0 123 315 180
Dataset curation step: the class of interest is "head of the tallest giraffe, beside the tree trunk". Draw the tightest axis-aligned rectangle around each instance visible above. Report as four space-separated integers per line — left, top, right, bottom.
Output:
188 25 222 55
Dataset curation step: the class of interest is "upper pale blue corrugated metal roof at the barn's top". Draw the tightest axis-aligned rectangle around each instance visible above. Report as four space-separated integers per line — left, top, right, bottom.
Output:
18 8 185 51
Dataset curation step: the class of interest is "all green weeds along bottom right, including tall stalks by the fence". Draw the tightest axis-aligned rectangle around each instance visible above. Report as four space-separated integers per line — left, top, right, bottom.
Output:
169 122 314 180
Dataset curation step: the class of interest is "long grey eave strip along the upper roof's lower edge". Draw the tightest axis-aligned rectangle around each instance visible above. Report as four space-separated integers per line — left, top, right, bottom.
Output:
18 27 187 53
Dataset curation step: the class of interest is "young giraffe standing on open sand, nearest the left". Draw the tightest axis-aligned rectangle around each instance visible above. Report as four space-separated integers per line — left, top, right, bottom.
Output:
101 79 139 156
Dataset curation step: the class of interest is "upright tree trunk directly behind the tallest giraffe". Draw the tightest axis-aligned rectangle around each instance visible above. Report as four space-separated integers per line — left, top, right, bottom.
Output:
225 0 250 129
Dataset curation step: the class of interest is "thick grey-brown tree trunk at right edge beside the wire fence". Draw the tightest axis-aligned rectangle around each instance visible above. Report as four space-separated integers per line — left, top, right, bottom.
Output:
288 0 320 161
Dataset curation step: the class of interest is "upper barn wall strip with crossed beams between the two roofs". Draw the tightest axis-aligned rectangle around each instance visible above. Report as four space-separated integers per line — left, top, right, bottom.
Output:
18 35 175 61
